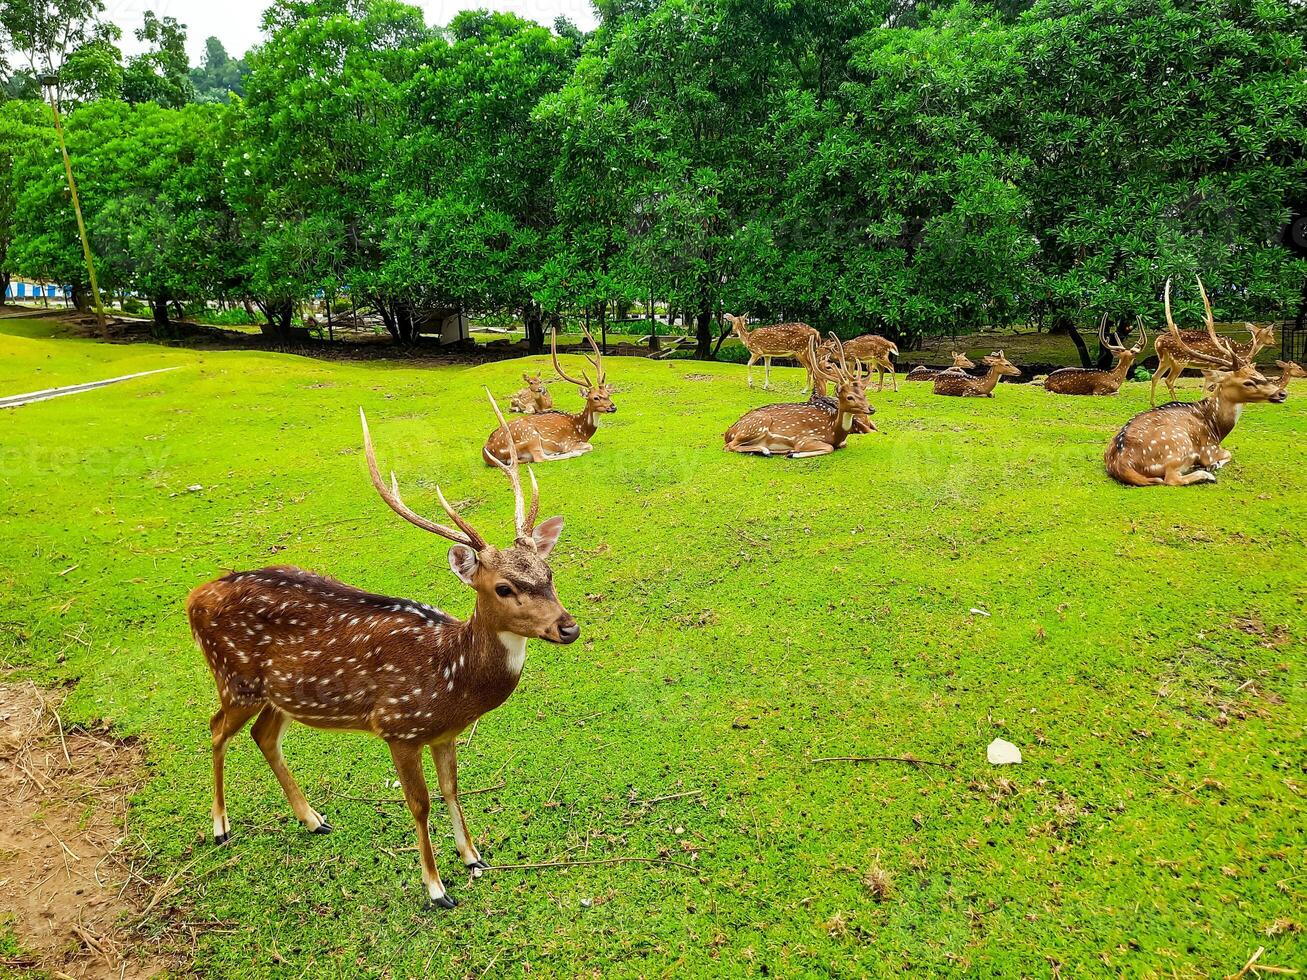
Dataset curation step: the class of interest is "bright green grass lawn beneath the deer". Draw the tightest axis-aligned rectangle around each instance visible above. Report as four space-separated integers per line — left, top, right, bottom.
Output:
0 321 1307 977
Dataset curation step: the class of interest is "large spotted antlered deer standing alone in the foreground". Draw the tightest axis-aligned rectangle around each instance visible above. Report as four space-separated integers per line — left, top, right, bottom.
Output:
187 391 580 908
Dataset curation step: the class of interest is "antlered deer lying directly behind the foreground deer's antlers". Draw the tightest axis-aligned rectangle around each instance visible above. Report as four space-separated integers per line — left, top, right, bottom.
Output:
481 331 617 465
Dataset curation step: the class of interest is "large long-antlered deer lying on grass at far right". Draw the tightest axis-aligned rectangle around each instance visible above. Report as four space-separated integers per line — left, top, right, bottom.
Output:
1103 280 1287 486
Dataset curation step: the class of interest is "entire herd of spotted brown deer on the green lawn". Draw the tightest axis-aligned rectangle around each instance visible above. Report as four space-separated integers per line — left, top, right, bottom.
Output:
187 281 1307 908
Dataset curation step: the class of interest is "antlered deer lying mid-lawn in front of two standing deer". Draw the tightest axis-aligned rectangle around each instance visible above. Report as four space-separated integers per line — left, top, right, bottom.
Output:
725 340 872 460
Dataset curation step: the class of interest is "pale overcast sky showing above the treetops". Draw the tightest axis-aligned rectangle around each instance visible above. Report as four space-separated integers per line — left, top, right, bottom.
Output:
105 0 595 64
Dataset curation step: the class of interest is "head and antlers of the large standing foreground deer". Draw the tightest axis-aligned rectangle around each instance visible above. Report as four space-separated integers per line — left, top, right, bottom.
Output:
358 389 580 643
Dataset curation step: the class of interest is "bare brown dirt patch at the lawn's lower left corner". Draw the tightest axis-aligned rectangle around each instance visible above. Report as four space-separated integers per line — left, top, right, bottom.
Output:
0 683 176 980
